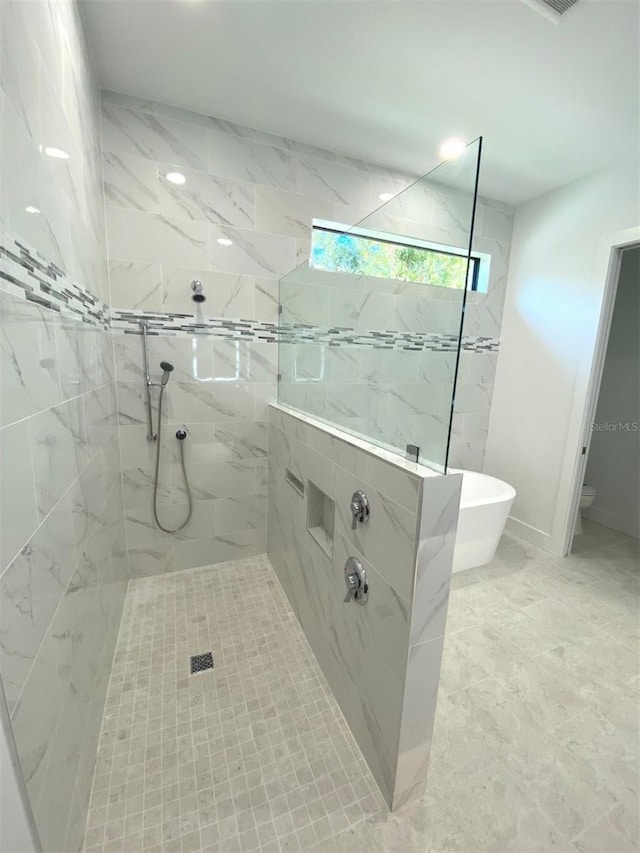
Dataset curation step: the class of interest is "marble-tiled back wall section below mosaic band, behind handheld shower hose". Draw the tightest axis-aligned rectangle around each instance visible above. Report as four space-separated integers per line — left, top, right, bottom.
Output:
114 333 277 577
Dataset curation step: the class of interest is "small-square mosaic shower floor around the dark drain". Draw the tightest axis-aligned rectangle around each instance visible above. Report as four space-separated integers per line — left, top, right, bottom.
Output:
85 556 385 853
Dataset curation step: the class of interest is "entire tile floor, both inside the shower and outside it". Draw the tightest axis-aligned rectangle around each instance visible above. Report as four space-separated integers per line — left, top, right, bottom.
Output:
86 522 640 853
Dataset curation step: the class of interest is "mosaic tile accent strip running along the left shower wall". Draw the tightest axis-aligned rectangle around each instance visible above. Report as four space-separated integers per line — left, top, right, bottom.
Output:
0 232 109 329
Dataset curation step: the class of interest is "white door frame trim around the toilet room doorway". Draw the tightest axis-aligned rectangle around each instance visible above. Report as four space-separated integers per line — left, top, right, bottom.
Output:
562 227 640 556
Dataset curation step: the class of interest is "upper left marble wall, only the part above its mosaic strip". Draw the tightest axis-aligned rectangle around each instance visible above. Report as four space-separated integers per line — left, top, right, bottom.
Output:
0 0 108 302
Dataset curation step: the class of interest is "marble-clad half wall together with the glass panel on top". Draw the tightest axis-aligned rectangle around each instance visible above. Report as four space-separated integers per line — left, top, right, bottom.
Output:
267 139 484 804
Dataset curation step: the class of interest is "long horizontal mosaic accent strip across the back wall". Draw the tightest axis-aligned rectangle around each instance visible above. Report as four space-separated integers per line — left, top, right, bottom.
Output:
111 311 499 352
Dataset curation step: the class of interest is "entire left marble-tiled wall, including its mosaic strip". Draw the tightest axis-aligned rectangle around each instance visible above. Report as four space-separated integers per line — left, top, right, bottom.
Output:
0 0 128 851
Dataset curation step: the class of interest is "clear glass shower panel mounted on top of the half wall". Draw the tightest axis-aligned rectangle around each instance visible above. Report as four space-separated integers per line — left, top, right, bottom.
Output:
278 140 481 471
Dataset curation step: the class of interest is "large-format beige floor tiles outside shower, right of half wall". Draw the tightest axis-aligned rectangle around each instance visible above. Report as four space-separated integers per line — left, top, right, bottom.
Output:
422 522 640 853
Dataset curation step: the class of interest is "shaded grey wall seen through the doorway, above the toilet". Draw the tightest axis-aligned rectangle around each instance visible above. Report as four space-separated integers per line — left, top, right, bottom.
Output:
585 248 640 537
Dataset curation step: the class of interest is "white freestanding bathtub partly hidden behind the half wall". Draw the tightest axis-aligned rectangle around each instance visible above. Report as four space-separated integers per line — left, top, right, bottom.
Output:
449 468 516 572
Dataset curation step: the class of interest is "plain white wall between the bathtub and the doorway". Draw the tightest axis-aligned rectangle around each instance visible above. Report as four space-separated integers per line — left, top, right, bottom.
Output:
484 165 640 554
